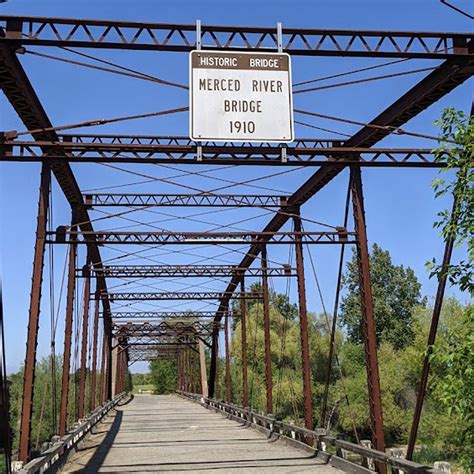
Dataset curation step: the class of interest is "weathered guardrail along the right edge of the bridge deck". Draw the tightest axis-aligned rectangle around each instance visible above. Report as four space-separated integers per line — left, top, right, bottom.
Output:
177 391 441 474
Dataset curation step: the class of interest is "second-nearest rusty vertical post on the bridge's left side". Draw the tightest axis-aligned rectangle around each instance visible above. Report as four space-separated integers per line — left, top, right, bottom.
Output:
59 207 77 436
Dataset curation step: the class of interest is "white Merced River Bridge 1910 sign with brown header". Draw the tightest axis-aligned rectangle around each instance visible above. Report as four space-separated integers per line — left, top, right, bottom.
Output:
189 50 294 142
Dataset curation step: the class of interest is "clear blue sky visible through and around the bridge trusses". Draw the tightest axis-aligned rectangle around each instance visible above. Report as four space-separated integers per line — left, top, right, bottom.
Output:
0 0 472 372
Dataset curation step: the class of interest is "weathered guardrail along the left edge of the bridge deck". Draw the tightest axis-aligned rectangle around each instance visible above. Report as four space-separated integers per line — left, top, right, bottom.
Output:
12 392 126 474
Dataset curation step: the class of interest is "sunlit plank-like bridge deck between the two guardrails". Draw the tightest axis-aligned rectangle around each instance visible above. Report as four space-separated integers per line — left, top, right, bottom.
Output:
62 395 340 473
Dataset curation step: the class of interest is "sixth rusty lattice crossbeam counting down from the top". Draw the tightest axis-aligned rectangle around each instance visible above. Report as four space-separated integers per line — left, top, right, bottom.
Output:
91 291 262 302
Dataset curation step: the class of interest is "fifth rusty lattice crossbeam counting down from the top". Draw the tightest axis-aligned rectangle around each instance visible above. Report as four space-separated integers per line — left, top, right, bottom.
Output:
80 264 296 278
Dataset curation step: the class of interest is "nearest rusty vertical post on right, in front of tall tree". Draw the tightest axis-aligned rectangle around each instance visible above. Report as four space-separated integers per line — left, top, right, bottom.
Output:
351 166 386 462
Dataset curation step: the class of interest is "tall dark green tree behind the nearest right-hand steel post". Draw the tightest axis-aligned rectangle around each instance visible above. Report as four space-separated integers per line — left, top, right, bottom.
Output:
341 244 425 349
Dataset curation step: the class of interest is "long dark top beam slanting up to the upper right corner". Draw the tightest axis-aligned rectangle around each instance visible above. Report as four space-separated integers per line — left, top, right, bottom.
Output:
216 40 474 334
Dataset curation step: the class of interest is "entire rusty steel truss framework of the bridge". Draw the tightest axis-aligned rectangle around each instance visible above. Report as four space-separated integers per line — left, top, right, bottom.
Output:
0 15 474 473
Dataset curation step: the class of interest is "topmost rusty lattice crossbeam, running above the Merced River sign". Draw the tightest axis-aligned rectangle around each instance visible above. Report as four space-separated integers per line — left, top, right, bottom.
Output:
0 15 471 59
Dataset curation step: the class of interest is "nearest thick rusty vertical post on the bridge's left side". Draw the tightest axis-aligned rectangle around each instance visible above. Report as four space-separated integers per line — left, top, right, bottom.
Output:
18 163 51 463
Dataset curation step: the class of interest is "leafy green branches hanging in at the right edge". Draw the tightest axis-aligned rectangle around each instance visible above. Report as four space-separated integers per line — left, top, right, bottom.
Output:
427 107 474 295
